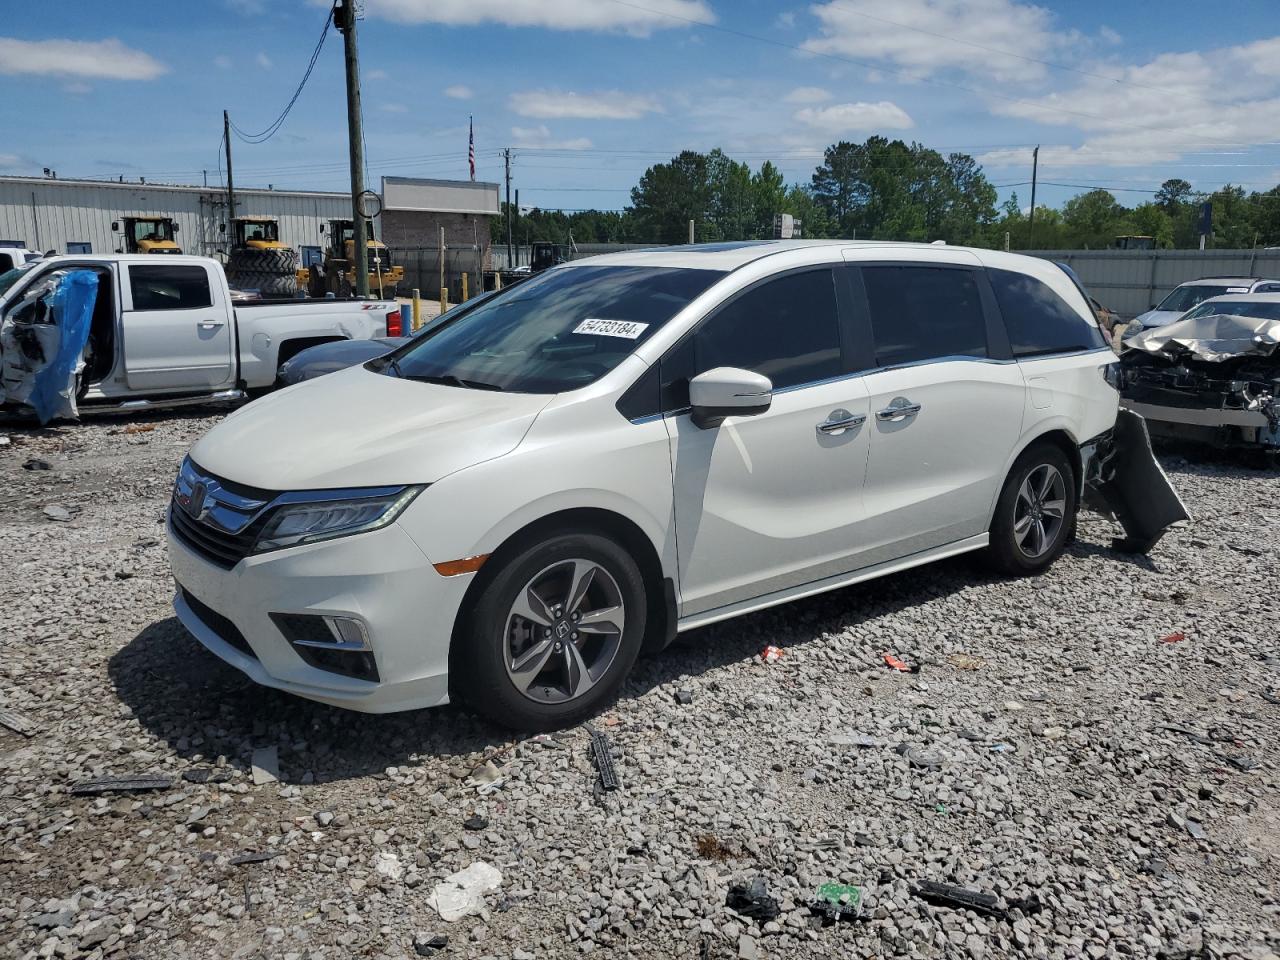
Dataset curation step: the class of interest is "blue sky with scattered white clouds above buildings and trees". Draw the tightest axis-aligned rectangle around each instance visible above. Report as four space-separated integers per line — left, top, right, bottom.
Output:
0 0 1280 209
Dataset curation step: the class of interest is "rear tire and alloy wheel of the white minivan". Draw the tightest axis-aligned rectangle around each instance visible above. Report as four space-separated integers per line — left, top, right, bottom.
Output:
987 443 1079 576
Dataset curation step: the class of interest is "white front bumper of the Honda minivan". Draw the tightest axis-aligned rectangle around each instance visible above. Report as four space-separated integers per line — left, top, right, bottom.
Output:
165 522 471 713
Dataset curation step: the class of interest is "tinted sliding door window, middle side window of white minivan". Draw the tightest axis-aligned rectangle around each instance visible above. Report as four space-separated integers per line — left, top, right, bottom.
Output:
863 266 987 366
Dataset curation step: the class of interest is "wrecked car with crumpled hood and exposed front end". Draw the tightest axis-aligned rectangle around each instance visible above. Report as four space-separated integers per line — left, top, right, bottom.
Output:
1120 293 1280 456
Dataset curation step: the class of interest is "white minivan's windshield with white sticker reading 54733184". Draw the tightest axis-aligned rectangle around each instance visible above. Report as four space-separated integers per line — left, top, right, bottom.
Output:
371 266 724 393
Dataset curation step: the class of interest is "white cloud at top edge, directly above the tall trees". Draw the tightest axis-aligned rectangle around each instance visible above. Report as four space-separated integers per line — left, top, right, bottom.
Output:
804 0 1059 83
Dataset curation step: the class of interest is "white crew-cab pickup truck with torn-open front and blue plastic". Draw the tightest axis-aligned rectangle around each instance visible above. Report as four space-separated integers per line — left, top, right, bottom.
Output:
0 253 402 419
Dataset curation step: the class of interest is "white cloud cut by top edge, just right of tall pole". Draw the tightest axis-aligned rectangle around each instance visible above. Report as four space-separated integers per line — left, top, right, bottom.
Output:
365 0 716 37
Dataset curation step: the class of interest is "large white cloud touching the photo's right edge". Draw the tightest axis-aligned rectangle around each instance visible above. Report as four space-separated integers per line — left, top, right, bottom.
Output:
979 38 1280 168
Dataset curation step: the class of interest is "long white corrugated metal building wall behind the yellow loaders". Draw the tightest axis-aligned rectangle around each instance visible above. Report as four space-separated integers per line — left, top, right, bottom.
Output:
0 177 355 255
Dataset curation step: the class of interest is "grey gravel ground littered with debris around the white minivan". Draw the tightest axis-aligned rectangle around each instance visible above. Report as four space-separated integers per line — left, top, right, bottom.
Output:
0 416 1280 960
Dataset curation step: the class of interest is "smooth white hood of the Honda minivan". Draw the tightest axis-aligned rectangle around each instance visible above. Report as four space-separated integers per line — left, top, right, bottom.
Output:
191 366 552 490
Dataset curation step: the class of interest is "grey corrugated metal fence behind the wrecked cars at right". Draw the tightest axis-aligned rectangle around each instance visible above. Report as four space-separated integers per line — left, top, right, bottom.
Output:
1025 250 1280 317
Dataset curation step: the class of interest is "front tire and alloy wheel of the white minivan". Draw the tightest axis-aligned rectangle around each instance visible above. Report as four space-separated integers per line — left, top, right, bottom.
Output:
451 531 648 731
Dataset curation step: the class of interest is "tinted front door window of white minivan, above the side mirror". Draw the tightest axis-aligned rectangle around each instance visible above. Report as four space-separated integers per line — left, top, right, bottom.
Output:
694 268 841 389
